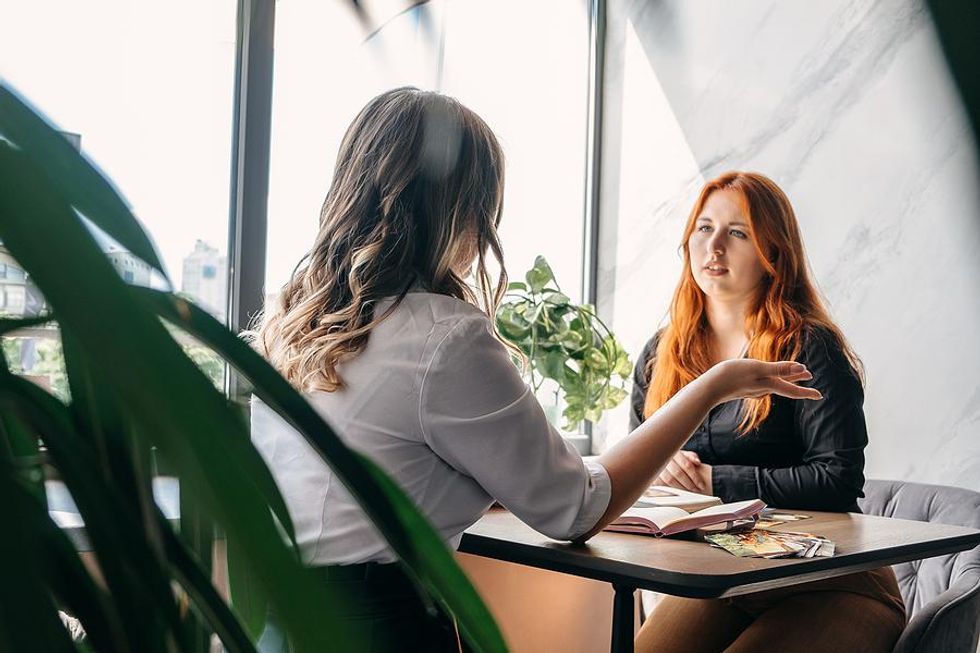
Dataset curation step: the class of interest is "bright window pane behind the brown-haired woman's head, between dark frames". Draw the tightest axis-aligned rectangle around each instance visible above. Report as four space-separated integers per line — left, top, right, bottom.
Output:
266 0 588 299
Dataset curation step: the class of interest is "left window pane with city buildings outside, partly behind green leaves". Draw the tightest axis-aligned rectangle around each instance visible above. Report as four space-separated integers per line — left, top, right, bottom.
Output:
0 0 238 392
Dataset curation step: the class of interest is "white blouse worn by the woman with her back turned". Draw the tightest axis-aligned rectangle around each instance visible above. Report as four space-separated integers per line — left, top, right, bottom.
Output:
252 292 610 565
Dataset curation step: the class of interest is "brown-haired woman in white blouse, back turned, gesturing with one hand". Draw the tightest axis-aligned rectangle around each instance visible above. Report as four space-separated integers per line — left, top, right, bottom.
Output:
252 93 819 651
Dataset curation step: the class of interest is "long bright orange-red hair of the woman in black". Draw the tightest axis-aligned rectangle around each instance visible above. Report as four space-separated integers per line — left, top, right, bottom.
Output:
644 172 863 433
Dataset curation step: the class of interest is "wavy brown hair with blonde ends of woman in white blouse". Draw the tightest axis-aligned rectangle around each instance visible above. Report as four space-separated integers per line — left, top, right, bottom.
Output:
251 87 507 392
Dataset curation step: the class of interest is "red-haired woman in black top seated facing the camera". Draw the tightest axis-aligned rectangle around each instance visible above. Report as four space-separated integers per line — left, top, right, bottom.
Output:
631 172 905 653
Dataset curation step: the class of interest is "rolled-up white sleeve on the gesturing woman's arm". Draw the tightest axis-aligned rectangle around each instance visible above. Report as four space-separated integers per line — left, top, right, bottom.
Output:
419 315 610 540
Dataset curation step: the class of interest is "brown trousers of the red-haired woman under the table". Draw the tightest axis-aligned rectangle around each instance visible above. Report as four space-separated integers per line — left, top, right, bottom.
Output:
635 567 905 653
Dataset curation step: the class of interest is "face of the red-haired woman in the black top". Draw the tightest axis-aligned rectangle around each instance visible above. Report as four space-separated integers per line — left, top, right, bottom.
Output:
687 190 766 302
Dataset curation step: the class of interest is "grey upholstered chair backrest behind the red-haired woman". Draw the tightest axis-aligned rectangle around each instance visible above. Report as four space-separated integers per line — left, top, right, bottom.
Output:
858 480 980 617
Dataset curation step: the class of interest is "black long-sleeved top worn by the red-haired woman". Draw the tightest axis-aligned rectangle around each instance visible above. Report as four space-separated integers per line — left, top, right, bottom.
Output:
630 328 868 512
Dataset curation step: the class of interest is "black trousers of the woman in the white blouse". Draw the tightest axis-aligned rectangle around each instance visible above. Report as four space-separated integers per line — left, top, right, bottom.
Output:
258 562 465 653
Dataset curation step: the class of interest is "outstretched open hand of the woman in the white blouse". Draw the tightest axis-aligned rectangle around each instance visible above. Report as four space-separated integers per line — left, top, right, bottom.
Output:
706 358 823 403
